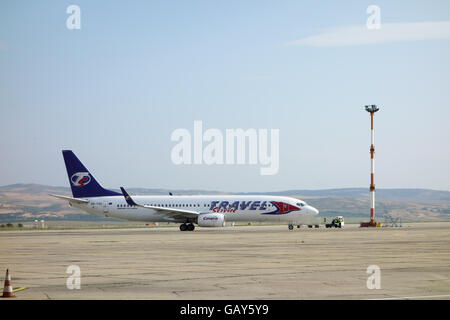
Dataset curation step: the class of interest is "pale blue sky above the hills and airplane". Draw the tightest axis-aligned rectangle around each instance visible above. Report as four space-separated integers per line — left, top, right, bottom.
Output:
0 0 450 191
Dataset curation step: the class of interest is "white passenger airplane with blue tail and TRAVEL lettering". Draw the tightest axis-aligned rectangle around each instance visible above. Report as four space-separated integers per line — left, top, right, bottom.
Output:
50 150 319 231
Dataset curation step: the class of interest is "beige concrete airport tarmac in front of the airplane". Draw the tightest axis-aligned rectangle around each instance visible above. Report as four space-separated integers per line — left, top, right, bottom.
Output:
0 222 450 300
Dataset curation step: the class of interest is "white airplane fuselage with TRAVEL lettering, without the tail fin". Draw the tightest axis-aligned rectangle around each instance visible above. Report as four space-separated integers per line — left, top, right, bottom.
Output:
71 195 318 223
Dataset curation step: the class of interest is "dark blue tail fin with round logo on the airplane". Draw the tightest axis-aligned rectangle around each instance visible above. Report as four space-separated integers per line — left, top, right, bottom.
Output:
63 150 121 198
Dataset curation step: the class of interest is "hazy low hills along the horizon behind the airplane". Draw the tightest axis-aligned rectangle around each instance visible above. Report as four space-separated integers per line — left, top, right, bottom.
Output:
0 184 450 223
